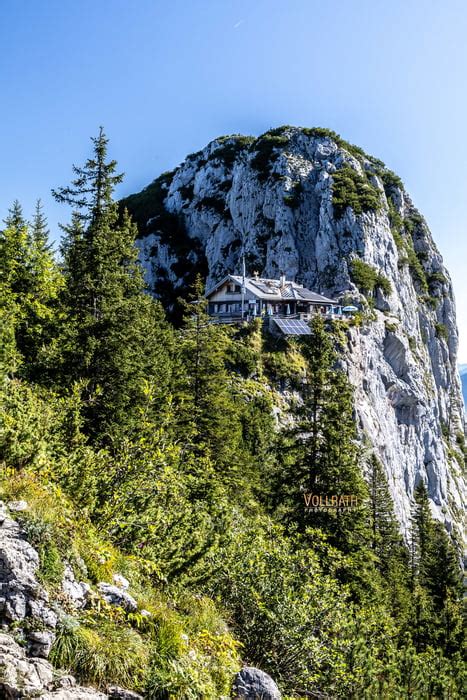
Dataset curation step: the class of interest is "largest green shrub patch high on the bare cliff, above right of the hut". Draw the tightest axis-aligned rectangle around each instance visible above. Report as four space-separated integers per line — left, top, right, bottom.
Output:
332 164 381 218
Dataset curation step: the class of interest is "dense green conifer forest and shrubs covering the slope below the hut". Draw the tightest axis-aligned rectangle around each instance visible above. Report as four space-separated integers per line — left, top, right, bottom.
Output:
0 130 466 700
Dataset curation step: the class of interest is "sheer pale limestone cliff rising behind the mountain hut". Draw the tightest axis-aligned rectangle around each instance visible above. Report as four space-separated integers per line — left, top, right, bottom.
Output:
124 127 466 540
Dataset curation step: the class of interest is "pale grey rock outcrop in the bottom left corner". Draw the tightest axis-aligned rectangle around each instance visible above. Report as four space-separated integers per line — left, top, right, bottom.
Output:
0 501 141 700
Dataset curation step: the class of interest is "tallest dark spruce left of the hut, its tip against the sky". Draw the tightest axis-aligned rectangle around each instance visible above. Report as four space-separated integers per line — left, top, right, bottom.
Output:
53 128 175 442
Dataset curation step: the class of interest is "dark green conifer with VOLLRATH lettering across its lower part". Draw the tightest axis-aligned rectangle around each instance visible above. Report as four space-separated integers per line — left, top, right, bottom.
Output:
281 317 368 553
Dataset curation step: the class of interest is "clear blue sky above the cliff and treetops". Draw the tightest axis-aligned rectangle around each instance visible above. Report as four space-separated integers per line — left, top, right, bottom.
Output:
0 0 467 362
